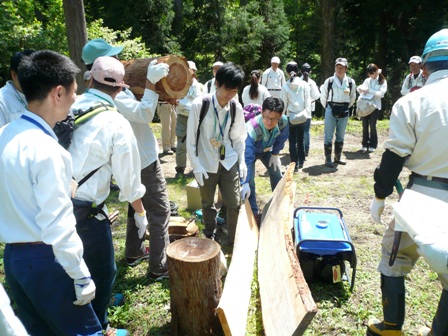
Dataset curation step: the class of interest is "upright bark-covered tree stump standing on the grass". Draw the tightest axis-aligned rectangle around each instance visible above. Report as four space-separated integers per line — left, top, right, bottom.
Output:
167 237 222 336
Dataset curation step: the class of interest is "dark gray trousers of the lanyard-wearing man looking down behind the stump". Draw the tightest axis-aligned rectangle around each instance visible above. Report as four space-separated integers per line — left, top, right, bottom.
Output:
200 163 241 244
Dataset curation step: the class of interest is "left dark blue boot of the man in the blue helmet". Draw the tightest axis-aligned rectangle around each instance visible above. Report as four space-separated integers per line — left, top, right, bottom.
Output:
367 274 405 336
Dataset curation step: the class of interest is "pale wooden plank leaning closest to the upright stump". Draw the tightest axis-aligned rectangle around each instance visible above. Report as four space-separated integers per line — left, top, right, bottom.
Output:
217 200 258 336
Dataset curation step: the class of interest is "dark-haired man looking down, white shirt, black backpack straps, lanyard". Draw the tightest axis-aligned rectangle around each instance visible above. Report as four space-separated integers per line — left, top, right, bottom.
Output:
187 63 247 245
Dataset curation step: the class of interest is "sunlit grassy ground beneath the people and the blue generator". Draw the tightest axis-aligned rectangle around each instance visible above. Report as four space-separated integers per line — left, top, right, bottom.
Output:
0 119 441 336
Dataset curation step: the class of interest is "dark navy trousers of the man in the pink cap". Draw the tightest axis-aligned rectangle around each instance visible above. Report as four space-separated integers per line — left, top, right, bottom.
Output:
76 217 117 329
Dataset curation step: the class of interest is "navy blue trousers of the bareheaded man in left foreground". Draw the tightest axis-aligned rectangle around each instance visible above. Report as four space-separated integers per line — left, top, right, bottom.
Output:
4 244 103 336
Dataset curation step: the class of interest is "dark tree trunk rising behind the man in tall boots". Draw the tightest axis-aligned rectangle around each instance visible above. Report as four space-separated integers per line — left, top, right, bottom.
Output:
321 0 335 82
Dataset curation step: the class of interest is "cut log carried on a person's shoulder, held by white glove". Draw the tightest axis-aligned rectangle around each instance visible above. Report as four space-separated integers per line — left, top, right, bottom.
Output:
122 55 193 101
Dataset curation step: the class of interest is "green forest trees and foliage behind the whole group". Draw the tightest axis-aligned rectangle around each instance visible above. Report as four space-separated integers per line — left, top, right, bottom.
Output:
0 0 448 116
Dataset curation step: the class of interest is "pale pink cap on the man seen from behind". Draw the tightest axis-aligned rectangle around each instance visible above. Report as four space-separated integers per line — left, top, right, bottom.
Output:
90 56 129 88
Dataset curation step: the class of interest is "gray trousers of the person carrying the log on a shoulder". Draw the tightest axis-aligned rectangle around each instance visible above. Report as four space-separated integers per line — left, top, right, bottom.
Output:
125 160 171 273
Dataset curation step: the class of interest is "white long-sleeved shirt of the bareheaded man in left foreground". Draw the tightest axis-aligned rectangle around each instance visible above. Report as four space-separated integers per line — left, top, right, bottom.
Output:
0 111 90 279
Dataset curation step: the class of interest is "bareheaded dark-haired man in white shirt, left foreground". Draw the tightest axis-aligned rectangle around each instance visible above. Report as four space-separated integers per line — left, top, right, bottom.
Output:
0 50 102 336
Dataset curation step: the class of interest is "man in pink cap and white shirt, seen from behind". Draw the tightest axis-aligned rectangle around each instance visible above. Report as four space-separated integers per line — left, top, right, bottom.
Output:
68 56 148 331
